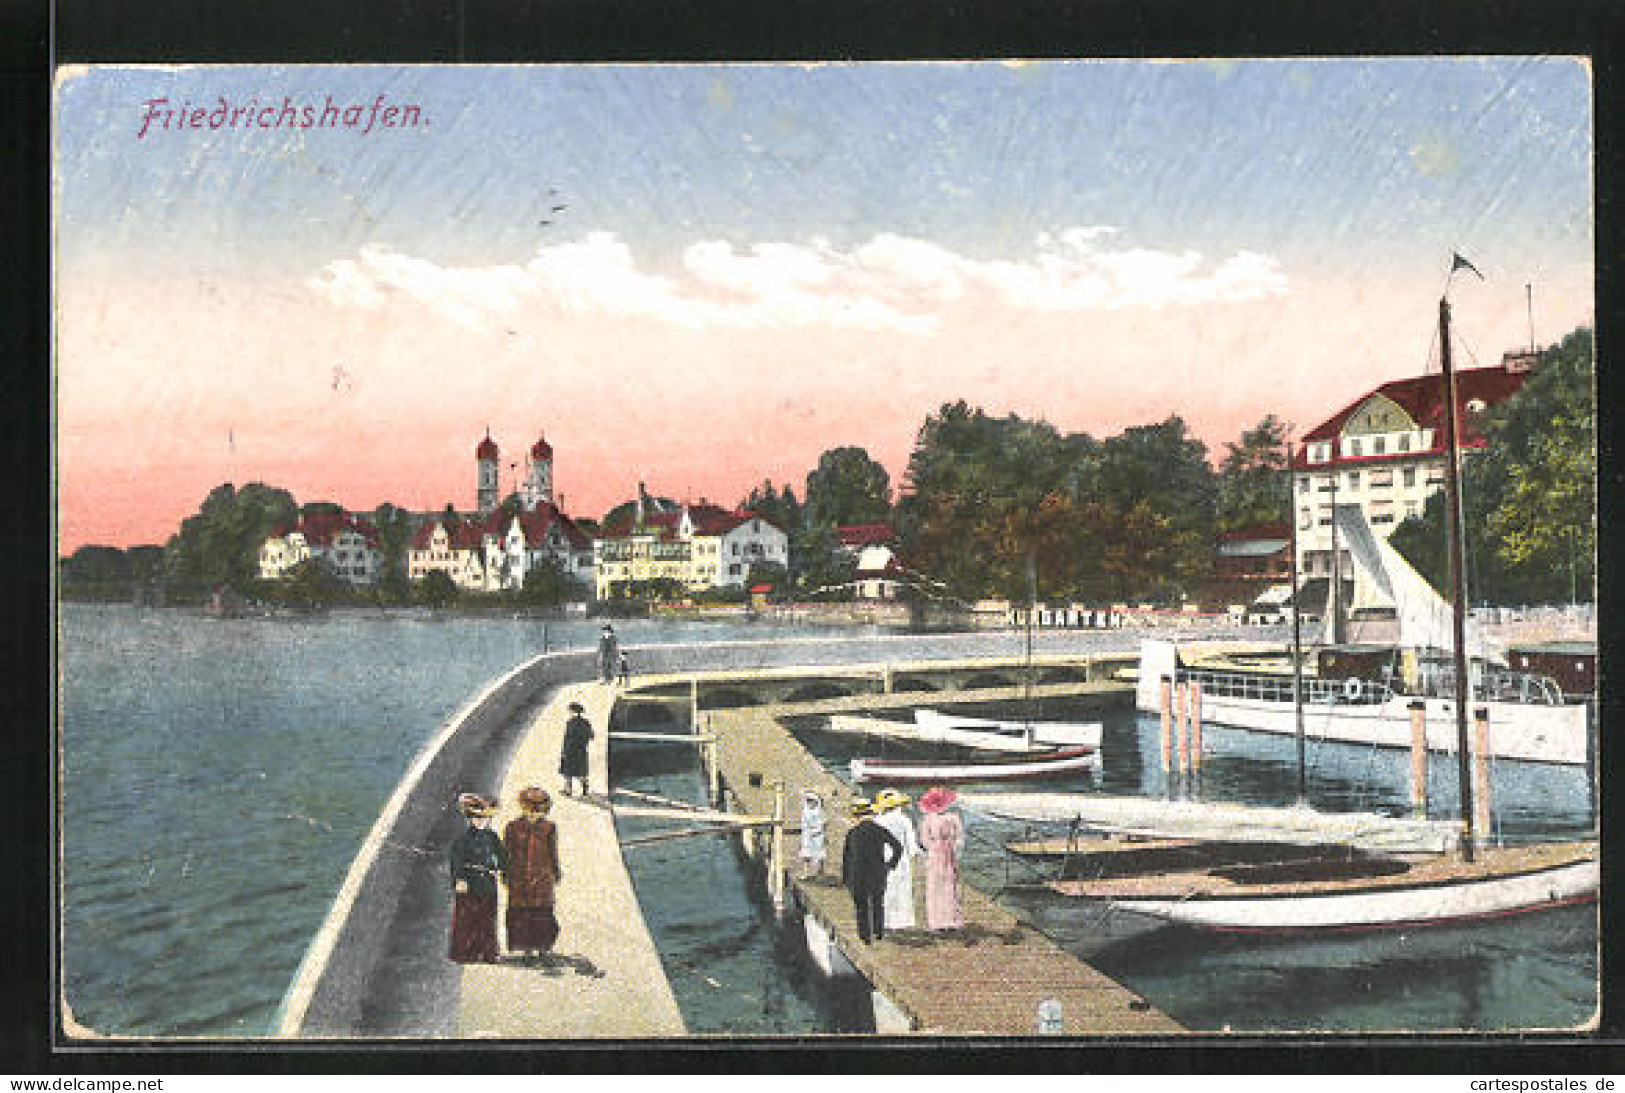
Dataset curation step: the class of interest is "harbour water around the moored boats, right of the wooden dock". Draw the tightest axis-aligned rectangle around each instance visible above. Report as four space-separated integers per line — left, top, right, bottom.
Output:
800 703 1597 1031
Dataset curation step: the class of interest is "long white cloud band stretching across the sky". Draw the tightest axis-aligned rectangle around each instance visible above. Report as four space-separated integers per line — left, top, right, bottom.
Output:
309 226 1287 335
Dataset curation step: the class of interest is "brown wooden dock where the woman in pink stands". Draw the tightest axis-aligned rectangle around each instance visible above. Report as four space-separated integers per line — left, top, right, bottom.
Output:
705 695 1183 1036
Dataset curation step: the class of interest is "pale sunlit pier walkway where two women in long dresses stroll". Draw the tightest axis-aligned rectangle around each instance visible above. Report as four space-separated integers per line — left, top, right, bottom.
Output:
457 684 686 1039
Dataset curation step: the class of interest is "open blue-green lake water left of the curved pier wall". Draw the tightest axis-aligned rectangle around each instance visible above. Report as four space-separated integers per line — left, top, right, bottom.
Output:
59 604 838 1036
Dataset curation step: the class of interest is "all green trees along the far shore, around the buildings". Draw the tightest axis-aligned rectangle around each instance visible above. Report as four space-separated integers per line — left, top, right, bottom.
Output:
59 328 1596 604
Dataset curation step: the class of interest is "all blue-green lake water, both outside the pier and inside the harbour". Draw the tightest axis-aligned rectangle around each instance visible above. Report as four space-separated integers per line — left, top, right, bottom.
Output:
59 604 1597 1038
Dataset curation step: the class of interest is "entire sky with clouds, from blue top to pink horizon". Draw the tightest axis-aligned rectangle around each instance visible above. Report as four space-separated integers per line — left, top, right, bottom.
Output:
54 57 1594 554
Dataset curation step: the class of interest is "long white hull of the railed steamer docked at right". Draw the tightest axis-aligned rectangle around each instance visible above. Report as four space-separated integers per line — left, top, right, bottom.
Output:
1136 642 1589 767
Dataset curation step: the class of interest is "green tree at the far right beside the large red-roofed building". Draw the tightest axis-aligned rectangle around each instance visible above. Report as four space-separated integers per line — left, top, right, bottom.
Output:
1389 328 1596 604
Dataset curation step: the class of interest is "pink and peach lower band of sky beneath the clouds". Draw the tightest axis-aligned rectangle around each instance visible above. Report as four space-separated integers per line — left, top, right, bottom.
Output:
57 250 1589 554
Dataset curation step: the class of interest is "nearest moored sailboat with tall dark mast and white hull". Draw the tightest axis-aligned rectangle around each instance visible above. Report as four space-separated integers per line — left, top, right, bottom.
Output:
962 272 1601 932
